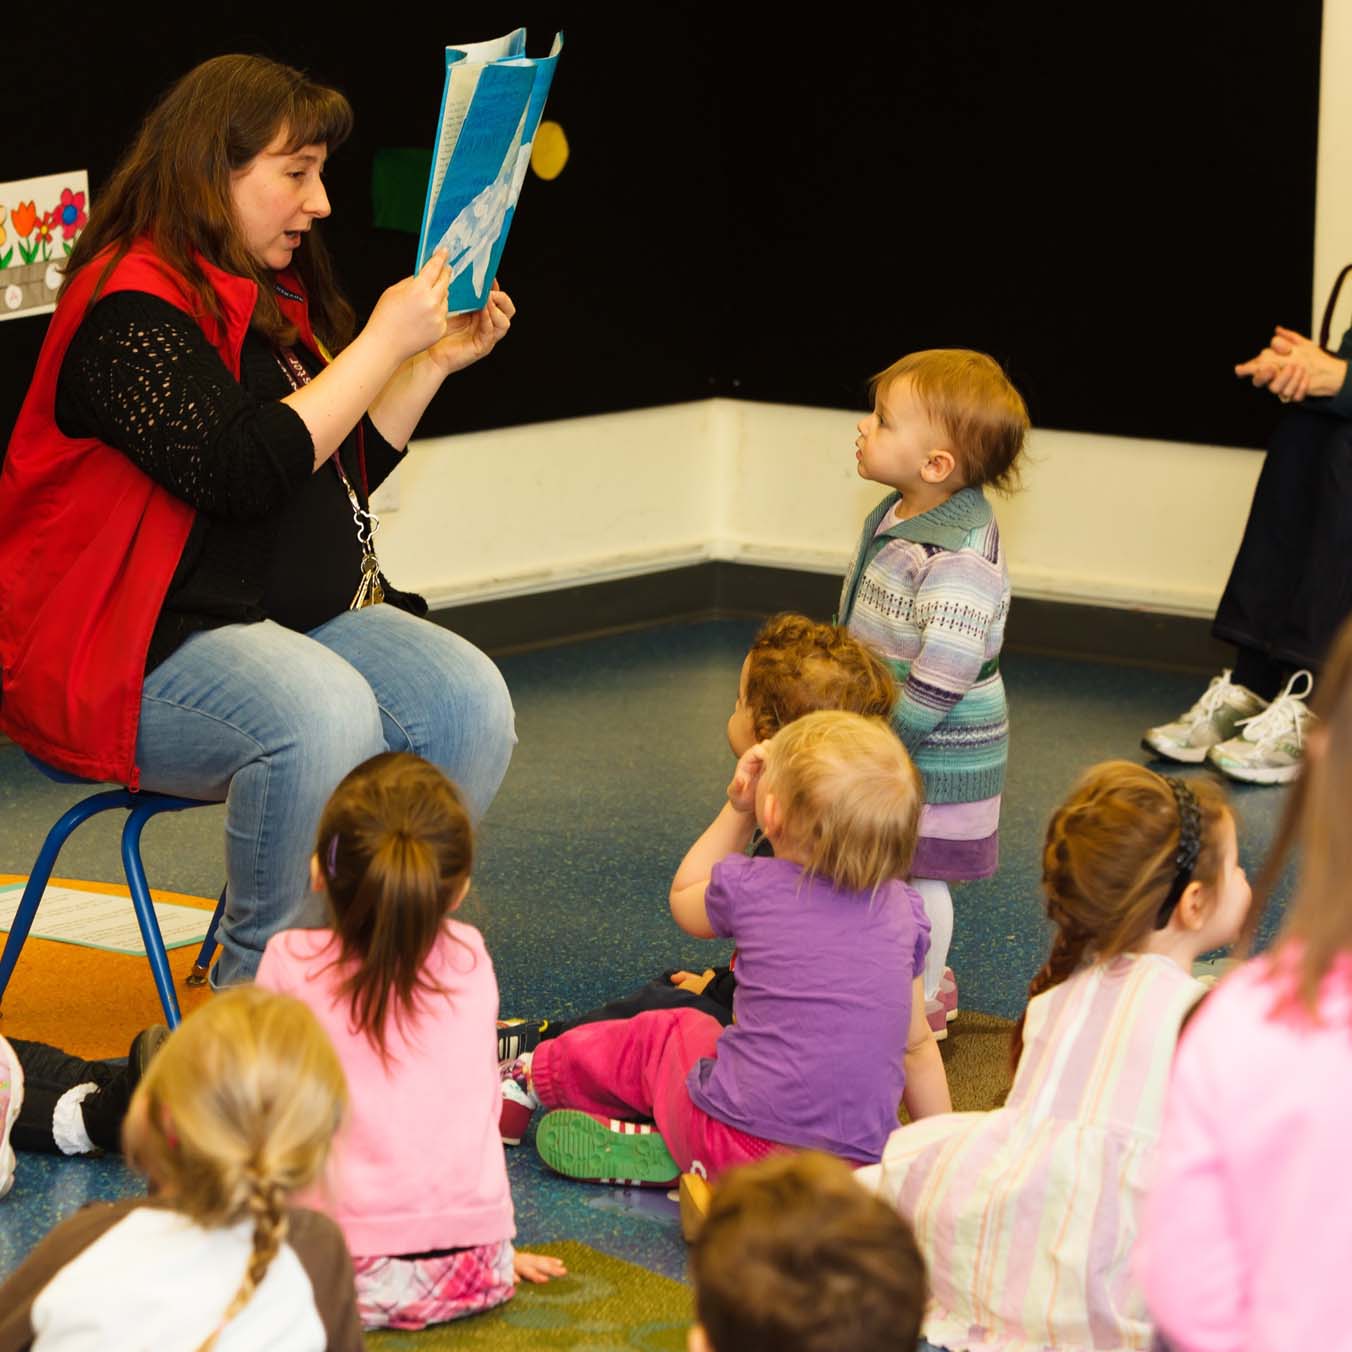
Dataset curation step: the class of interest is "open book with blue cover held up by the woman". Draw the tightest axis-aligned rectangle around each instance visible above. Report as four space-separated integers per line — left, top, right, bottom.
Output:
416 28 564 315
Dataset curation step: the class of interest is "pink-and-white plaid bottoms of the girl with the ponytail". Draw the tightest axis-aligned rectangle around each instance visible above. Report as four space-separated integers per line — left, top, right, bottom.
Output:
352 1240 516 1329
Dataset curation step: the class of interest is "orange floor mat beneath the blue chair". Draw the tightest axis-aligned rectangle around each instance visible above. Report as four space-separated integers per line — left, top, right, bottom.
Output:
0 873 216 1060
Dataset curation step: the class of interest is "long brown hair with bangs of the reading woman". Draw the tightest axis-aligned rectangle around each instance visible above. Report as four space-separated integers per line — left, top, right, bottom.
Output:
62 55 354 352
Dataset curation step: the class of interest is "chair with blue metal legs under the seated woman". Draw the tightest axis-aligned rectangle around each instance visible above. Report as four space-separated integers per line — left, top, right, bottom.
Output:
0 756 226 1028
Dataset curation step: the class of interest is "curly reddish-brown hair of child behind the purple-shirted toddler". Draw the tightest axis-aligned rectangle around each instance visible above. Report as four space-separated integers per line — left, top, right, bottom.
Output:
746 612 896 741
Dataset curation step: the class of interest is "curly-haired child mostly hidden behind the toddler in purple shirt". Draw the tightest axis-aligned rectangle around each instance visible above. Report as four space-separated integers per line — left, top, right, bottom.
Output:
499 612 896 1076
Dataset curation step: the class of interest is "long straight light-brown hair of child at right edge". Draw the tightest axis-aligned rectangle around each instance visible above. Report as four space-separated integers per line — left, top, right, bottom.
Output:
1242 621 1352 1014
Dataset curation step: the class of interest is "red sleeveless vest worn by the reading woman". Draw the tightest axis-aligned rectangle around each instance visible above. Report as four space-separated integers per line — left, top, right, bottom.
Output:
0 242 314 788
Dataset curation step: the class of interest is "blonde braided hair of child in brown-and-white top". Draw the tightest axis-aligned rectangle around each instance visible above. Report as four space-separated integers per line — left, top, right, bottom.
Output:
123 986 347 1352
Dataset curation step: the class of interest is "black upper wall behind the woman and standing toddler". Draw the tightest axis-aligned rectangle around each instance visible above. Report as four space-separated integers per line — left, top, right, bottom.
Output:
0 0 1319 445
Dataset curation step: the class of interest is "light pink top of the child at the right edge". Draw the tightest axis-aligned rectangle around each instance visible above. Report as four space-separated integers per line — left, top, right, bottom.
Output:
1137 957 1352 1352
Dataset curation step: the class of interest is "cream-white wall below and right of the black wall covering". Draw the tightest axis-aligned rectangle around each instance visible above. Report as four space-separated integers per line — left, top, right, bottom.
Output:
380 0 1352 615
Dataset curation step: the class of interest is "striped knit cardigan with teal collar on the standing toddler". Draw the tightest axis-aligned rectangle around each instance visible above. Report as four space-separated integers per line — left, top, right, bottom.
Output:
840 488 1010 803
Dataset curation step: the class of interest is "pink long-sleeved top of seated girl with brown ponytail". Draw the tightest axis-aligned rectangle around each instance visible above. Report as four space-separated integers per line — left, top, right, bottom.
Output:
257 921 515 1257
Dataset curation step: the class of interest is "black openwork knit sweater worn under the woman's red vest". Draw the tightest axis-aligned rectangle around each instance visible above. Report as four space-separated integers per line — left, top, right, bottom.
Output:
55 291 400 672
